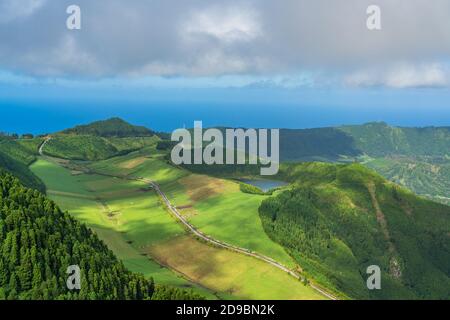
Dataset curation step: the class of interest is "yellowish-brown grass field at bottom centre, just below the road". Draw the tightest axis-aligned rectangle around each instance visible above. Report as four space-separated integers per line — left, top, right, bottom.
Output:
148 236 323 300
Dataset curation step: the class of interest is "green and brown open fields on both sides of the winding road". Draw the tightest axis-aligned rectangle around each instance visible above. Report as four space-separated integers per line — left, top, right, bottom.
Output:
31 157 322 299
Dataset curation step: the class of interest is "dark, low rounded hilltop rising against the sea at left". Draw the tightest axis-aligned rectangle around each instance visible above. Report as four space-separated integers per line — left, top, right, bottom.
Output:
61 118 154 138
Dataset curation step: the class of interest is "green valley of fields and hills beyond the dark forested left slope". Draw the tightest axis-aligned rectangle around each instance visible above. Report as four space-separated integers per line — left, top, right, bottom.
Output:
0 118 450 300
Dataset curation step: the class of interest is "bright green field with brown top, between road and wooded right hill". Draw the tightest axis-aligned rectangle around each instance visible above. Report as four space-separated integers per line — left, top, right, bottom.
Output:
181 175 295 267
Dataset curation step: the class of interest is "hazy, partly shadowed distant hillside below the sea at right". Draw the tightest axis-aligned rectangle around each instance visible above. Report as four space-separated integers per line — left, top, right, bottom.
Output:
280 122 450 203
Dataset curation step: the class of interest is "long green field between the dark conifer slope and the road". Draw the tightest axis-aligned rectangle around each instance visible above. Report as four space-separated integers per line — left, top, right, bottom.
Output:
31 159 215 298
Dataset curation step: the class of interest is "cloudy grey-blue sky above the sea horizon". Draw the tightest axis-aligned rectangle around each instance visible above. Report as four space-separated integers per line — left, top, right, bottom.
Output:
0 0 450 131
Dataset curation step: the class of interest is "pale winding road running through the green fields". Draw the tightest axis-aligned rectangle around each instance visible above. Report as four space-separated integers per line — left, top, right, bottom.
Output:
39 137 338 300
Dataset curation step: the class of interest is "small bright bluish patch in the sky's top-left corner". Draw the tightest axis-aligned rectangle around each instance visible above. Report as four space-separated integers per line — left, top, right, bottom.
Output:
0 0 47 23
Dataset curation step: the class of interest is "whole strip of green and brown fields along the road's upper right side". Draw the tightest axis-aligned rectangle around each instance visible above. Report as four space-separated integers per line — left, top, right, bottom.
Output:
91 149 295 267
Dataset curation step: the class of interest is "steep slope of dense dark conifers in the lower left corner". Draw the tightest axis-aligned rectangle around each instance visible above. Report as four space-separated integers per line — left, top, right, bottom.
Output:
0 174 199 300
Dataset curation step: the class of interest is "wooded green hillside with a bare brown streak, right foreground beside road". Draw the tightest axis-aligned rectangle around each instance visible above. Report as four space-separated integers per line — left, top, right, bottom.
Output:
259 163 450 299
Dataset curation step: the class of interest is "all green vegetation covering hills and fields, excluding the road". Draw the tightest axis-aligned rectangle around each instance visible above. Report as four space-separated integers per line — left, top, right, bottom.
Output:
0 118 450 300
